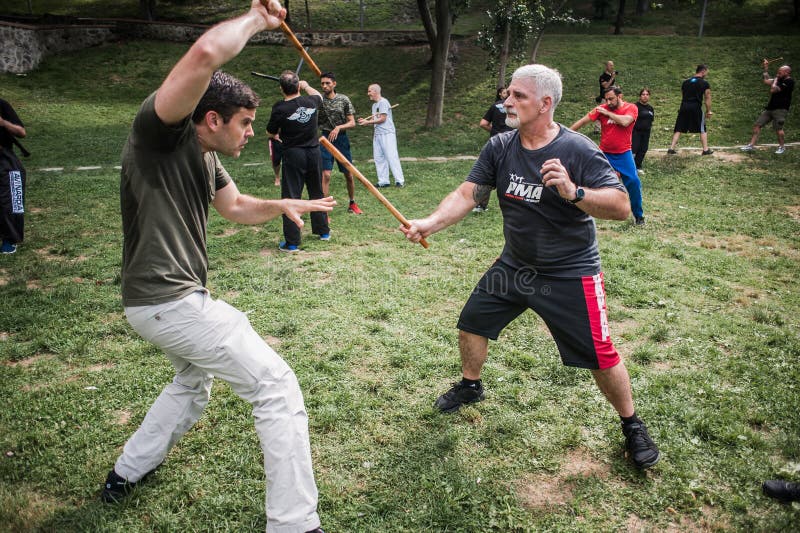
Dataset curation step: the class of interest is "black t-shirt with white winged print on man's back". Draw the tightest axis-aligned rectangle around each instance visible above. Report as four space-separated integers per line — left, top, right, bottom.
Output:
267 95 322 150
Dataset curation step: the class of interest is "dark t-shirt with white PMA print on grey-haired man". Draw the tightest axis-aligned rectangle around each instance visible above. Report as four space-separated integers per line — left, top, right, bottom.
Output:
466 124 625 277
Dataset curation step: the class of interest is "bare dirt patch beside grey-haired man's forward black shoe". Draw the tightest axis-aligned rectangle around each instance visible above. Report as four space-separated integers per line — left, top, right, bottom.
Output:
516 449 611 510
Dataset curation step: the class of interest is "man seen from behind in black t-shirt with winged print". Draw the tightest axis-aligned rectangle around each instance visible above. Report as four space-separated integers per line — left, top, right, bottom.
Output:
267 70 331 252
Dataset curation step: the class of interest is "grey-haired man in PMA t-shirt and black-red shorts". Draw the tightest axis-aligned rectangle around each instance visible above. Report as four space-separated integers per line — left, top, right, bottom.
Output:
401 65 660 468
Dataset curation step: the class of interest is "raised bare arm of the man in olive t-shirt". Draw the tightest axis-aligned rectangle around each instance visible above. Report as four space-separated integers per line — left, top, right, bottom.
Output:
155 0 286 124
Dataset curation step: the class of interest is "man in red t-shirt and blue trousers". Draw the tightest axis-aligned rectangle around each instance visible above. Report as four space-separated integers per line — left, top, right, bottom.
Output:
570 87 644 226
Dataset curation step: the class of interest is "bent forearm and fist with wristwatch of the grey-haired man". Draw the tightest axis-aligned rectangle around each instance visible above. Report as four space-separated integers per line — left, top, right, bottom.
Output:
541 159 631 220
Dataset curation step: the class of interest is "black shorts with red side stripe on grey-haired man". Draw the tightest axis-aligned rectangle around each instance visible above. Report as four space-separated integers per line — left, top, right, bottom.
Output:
458 260 620 369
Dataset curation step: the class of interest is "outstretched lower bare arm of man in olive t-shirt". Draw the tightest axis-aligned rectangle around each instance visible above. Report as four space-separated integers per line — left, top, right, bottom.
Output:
213 182 336 227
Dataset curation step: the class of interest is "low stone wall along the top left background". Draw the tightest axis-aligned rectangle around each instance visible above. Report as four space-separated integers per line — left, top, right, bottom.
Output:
0 19 427 73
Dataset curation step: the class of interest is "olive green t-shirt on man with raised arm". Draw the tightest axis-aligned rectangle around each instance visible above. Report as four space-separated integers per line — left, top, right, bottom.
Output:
120 93 231 307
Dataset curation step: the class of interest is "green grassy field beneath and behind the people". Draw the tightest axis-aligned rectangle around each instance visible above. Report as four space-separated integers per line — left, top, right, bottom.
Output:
0 3 800 532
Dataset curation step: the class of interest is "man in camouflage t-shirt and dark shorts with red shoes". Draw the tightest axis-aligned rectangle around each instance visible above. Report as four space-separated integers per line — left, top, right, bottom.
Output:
319 72 361 215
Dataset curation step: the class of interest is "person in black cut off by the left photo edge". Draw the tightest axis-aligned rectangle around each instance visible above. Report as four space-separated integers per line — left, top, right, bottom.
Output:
0 98 28 254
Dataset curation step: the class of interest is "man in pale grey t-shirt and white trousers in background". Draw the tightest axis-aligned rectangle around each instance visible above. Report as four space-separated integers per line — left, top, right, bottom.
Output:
358 83 405 188
